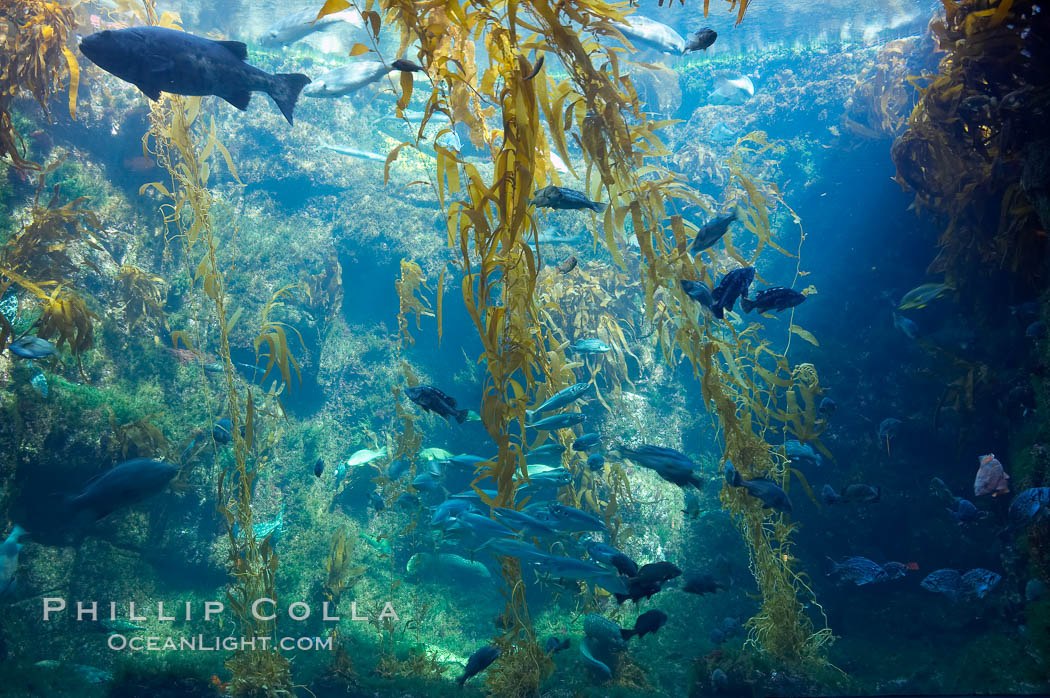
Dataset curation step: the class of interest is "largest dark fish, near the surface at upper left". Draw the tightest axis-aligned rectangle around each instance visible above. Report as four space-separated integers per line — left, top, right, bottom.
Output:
80 26 310 124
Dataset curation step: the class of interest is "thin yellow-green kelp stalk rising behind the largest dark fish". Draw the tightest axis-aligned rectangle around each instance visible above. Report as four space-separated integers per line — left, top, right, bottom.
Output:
142 0 298 696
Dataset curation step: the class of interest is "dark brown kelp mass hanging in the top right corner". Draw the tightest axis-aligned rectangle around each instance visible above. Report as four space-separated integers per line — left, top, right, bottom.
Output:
891 0 1050 295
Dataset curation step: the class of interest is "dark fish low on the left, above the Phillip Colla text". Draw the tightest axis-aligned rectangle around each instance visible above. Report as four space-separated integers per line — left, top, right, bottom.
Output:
68 458 179 521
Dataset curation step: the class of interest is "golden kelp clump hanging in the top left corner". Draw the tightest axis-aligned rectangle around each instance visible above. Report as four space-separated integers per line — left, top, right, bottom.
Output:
0 0 80 169
